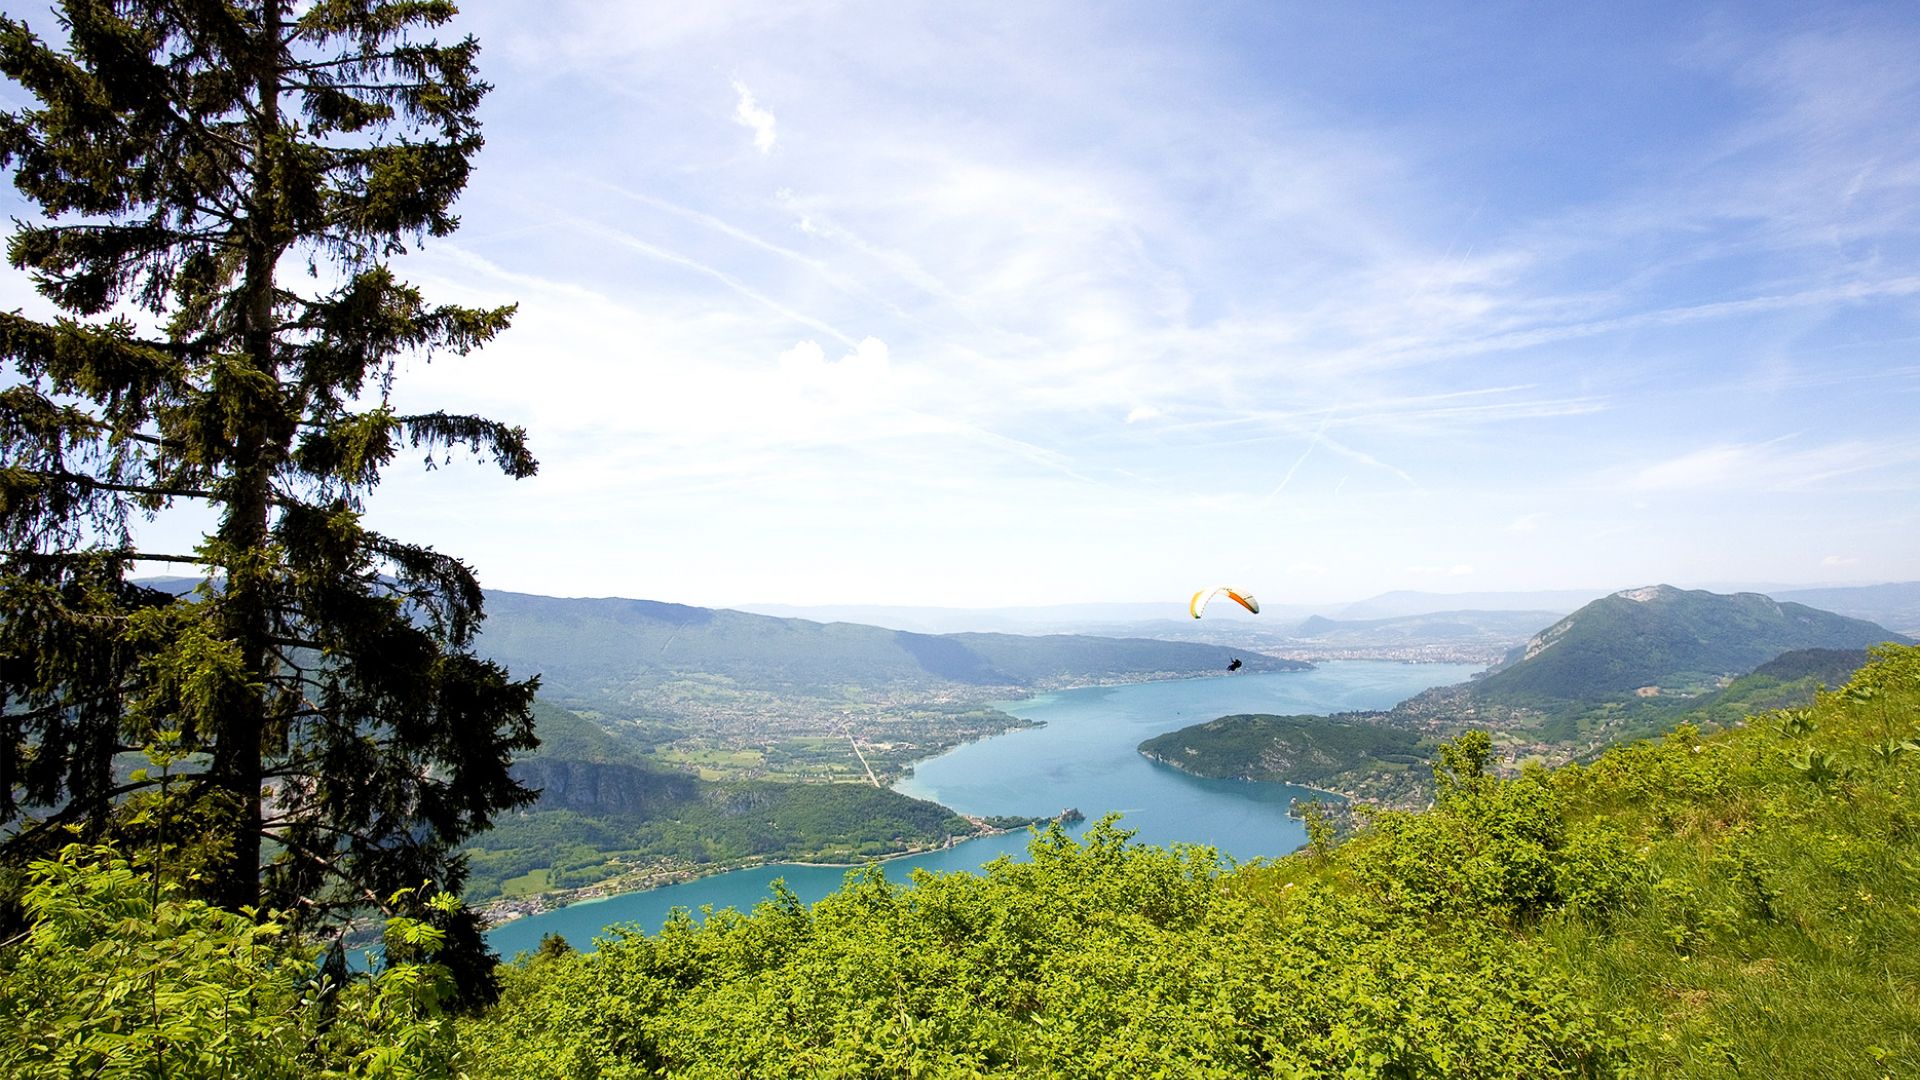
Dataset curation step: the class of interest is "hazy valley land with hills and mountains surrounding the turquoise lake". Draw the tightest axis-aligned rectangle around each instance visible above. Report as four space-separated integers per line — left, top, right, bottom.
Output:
456 586 1899 920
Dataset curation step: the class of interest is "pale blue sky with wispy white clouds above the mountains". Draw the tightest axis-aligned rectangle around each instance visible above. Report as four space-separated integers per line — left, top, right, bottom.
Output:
11 0 1920 607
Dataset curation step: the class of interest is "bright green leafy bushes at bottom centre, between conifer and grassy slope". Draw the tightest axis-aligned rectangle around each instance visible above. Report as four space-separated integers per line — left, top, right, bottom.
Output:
465 821 1617 1076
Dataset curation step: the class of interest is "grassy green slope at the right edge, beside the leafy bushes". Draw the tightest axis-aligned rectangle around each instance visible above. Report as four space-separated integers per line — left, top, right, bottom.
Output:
1540 641 1920 1078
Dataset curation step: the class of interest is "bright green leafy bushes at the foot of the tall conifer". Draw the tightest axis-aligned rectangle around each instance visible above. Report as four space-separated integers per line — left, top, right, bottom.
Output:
0 846 459 1080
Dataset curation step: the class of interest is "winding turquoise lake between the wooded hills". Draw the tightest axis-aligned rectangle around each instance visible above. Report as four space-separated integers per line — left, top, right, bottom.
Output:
488 661 1480 957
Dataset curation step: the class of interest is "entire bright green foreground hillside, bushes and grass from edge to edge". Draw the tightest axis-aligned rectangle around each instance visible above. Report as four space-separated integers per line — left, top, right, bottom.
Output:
15 648 1920 1078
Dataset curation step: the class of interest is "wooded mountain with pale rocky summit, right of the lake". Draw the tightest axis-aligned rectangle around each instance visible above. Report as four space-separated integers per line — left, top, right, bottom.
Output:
1473 584 1905 705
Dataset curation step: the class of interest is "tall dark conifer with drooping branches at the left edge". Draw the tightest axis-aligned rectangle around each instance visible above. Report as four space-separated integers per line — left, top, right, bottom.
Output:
0 0 536 992
